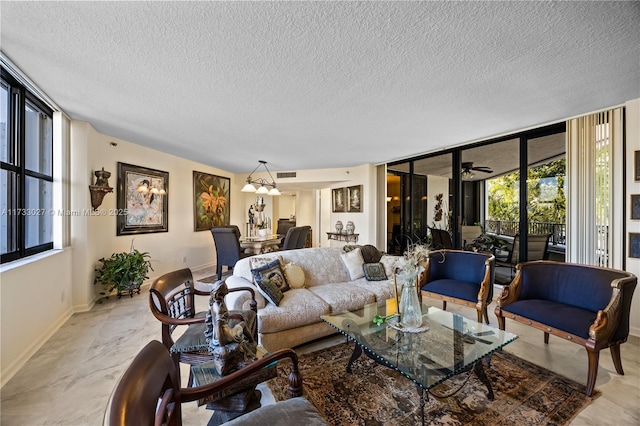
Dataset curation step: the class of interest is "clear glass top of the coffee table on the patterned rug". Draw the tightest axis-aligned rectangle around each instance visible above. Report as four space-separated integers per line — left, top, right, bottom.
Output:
321 303 518 390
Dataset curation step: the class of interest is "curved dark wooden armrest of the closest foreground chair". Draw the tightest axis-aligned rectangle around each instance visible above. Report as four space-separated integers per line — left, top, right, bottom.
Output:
180 349 302 402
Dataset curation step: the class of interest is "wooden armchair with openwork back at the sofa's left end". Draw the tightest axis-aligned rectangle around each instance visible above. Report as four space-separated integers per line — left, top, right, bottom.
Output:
149 268 258 386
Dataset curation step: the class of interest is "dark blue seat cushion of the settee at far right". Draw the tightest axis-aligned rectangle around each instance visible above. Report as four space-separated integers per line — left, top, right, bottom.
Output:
502 299 597 339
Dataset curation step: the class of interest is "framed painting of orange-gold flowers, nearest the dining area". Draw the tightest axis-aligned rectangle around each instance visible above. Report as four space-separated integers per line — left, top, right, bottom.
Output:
193 170 231 232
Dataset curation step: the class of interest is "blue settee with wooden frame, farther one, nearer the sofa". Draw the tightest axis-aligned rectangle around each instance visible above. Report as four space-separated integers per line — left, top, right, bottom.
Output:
420 250 495 324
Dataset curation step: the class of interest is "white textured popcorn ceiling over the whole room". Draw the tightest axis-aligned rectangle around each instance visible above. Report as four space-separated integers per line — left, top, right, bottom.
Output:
0 1 640 173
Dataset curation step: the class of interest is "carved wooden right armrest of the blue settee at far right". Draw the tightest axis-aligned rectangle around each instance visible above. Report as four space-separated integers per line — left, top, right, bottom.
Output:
589 277 637 343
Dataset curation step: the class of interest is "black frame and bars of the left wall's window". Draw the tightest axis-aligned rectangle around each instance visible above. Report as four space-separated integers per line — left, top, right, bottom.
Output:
0 67 55 264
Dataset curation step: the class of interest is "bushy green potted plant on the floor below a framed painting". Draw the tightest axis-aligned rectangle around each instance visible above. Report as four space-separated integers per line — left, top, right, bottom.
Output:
93 247 153 299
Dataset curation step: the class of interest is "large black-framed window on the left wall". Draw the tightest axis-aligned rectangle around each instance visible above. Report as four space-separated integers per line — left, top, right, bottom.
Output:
0 68 53 263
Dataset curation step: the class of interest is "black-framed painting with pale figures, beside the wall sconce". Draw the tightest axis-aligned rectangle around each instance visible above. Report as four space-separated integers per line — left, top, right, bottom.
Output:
116 162 169 235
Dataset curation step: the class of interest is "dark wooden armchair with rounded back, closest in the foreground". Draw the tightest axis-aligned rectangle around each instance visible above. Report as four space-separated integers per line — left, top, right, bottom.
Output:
103 340 326 426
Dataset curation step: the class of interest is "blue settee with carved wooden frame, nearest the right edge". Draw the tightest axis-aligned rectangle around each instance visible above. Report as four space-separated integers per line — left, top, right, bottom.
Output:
495 260 637 396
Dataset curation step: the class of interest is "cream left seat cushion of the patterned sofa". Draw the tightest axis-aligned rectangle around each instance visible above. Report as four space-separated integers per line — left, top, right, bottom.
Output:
258 288 331 333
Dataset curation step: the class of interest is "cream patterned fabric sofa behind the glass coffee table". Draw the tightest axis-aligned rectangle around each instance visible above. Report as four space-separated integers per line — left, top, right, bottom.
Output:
225 247 397 352
